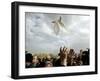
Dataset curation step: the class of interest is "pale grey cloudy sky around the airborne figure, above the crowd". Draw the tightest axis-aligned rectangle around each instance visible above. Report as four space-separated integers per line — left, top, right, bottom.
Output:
25 12 90 54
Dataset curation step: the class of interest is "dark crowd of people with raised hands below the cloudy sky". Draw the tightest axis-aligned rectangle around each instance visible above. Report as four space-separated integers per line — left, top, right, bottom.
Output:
25 47 90 68
